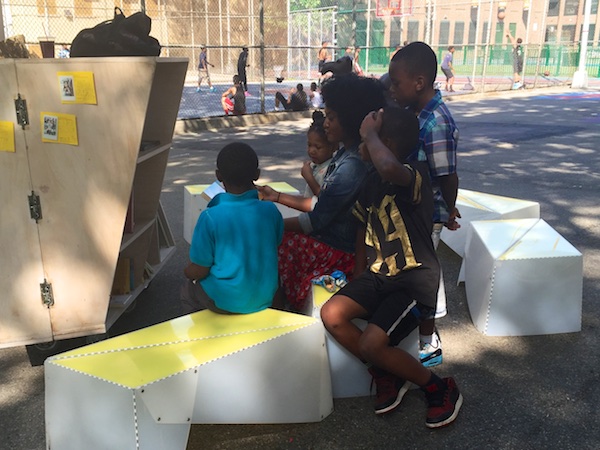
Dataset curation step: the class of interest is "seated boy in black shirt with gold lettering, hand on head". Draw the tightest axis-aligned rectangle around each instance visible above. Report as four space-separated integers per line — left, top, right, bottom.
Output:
321 107 463 428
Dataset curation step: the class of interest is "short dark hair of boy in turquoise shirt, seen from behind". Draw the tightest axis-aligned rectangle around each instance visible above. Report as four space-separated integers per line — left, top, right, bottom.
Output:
217 142 258 186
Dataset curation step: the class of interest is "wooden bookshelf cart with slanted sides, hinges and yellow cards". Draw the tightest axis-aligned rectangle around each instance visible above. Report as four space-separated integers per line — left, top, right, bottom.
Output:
0 57 188 362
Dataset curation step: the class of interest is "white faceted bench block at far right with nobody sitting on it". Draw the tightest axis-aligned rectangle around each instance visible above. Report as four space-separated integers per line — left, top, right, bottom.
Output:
465 219 583 336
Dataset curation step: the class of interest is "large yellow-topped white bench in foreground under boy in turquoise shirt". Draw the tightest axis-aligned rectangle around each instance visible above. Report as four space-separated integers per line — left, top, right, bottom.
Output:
45 309 333 450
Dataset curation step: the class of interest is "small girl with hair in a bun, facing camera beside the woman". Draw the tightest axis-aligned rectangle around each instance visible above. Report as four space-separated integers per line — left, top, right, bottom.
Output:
300 111 337 198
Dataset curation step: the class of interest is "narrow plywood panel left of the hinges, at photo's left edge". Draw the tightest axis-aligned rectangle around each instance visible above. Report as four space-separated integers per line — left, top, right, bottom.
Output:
0 59 52 347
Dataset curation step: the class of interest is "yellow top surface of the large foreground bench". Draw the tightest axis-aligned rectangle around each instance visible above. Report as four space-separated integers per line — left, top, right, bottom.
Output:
46 309 320 388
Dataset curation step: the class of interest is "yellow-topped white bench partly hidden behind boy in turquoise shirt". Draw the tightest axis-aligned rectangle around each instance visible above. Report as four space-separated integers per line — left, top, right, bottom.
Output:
183 181 300 244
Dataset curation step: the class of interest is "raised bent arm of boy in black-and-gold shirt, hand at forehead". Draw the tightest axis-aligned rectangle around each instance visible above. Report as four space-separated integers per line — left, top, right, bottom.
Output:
360 109 412 186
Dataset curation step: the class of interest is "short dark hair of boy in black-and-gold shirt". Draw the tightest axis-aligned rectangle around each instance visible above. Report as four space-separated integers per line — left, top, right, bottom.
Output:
379 106 419 160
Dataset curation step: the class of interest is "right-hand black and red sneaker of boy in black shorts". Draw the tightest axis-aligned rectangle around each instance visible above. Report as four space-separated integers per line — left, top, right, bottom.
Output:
421 377 463 428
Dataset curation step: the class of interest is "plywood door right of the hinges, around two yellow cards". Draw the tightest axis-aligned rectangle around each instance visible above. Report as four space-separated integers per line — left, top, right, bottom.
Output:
18 58 156 338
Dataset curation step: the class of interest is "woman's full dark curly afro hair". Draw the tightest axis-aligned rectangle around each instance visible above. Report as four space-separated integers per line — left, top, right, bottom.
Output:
321 73 386 142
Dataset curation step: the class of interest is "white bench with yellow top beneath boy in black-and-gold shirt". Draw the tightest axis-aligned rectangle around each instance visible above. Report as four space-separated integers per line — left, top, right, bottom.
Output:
306 286 419 398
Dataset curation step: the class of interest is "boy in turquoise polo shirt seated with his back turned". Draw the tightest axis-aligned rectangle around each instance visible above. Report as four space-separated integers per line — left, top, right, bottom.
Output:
182 142 283 314
